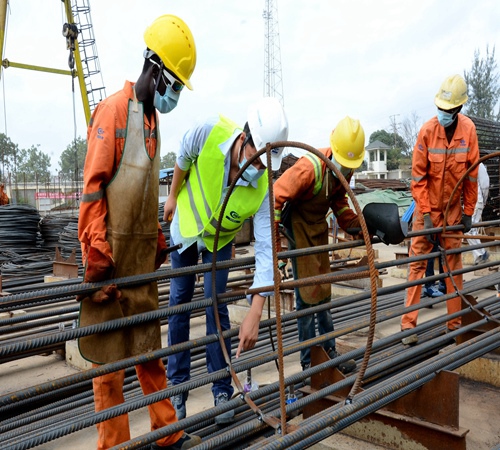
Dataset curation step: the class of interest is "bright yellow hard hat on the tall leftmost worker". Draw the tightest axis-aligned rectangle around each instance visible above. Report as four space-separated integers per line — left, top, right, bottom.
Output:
144 14 196 90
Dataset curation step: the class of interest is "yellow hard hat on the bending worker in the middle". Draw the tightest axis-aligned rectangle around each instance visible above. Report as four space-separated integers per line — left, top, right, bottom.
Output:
330 116 365 169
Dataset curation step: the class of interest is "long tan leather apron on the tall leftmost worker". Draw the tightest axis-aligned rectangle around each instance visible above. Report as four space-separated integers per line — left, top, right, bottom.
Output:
79 91 161 364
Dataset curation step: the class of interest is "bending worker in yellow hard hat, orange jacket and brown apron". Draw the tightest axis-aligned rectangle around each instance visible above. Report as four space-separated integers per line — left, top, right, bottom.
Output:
274 117 365 373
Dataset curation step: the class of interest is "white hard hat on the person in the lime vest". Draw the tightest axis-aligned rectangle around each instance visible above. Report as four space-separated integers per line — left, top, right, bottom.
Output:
247 97 288 170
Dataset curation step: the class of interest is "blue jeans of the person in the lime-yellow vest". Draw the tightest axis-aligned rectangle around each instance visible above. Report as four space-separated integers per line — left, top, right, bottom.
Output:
167 242 234 398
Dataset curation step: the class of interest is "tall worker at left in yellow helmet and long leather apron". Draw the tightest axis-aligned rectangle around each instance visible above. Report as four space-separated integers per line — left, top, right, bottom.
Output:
78 15 201 449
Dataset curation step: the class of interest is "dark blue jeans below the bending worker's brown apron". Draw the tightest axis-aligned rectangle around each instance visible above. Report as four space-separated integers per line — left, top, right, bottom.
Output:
295 289 335 368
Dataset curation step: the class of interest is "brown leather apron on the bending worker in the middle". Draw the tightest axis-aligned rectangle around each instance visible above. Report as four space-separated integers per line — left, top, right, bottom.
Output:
285 169 334 305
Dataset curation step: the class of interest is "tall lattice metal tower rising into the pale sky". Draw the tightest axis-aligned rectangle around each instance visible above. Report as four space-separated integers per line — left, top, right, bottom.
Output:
262 0 285 106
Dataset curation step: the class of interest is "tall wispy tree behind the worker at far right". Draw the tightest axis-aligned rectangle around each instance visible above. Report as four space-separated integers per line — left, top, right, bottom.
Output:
464 46 500 120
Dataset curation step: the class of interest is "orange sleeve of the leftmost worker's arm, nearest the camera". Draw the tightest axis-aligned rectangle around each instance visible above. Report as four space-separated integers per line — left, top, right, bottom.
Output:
78 102 117 262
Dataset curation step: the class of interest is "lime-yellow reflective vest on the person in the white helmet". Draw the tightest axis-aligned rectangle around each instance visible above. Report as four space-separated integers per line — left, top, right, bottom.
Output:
177 116 268 251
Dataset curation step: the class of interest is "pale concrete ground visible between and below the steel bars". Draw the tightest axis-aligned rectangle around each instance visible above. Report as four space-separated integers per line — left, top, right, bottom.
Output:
0 244 500 450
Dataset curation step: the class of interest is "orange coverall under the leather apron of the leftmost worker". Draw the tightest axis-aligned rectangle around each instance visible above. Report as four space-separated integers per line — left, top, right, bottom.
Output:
78 82 183 449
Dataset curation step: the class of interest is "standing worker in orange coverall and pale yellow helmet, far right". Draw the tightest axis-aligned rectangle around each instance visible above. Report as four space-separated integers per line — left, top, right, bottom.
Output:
401 75 479 344
